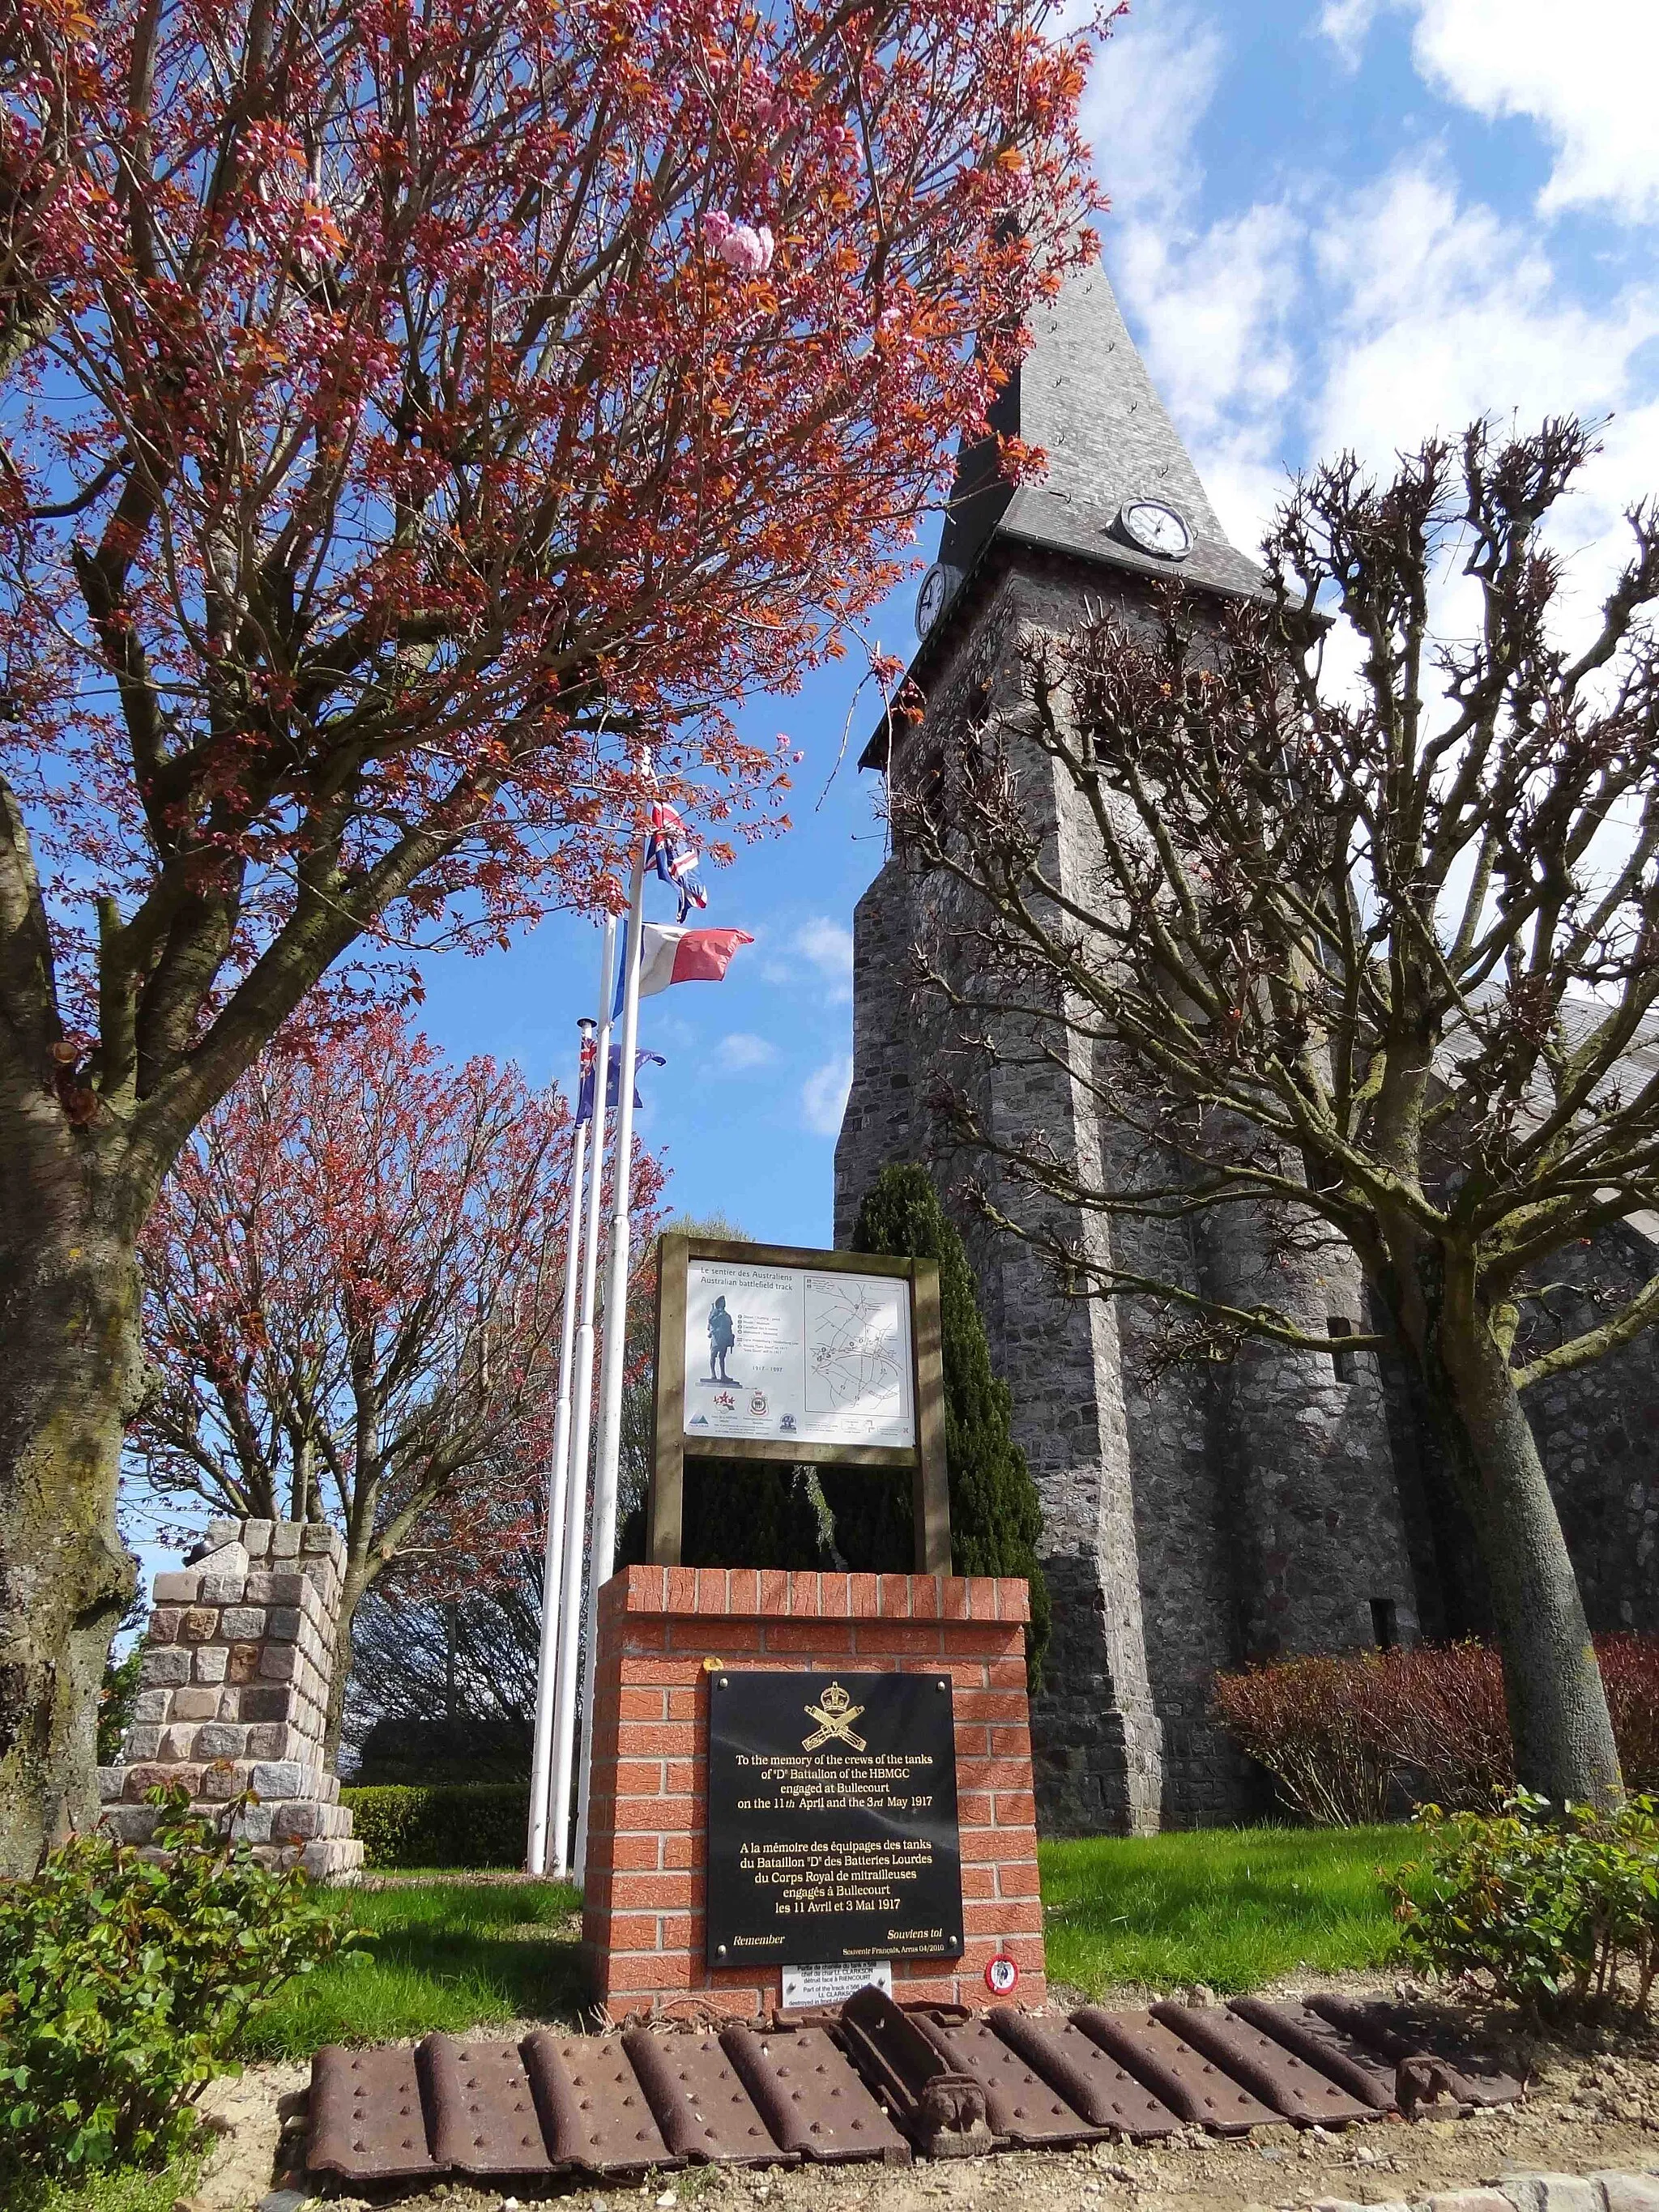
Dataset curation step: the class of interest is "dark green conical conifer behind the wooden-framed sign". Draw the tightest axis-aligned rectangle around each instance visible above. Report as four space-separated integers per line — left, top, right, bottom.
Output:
821 1161 1051 1692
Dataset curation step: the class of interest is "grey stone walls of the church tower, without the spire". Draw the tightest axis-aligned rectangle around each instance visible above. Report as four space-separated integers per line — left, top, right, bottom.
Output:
836 569 1442 1831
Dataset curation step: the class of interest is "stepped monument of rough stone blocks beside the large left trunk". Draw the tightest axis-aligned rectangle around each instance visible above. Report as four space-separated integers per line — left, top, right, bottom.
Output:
97 1519 363 1882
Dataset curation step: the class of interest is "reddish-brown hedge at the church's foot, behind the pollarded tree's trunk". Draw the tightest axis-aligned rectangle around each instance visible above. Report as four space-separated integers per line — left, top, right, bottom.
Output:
1214 1634 1659 1827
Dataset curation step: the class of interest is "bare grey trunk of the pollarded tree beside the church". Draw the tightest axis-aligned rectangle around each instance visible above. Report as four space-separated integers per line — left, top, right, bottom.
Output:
1429 1307 1623 1805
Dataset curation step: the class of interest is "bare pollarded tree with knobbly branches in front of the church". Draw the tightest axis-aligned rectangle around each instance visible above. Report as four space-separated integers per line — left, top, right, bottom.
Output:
891 420 1659 1801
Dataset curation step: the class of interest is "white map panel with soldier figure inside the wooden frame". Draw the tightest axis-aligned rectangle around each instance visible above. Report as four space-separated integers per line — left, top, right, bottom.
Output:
684 1259 915 1451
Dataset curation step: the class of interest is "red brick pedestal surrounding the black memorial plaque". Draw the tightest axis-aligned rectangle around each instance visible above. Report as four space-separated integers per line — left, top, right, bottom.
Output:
582 1566 1044 2019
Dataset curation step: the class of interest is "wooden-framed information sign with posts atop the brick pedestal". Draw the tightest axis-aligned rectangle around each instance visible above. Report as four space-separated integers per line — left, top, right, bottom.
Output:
648 1232 951 1575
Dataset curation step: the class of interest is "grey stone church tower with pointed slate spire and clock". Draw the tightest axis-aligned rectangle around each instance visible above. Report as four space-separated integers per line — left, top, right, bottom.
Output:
836 267 1427 1834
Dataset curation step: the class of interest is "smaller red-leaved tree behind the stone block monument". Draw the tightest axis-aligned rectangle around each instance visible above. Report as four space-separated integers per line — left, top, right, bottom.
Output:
128 1011 661 1758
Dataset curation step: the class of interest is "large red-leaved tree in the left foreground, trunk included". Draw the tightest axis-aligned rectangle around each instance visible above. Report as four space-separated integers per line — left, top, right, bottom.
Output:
0 0 1093 1869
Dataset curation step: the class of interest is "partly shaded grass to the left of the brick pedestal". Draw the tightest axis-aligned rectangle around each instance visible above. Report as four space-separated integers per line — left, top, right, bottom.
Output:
243 1880 582 2060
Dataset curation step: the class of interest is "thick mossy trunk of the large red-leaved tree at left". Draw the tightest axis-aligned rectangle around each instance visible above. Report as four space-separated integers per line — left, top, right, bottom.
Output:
0 1132 143 1876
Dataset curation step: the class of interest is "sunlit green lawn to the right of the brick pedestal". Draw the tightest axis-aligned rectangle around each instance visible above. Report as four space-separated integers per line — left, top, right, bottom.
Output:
1038 1827 1414 1995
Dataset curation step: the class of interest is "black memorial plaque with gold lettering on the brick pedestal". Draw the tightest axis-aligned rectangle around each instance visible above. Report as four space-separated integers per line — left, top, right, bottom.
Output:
708 1668 962 1967
